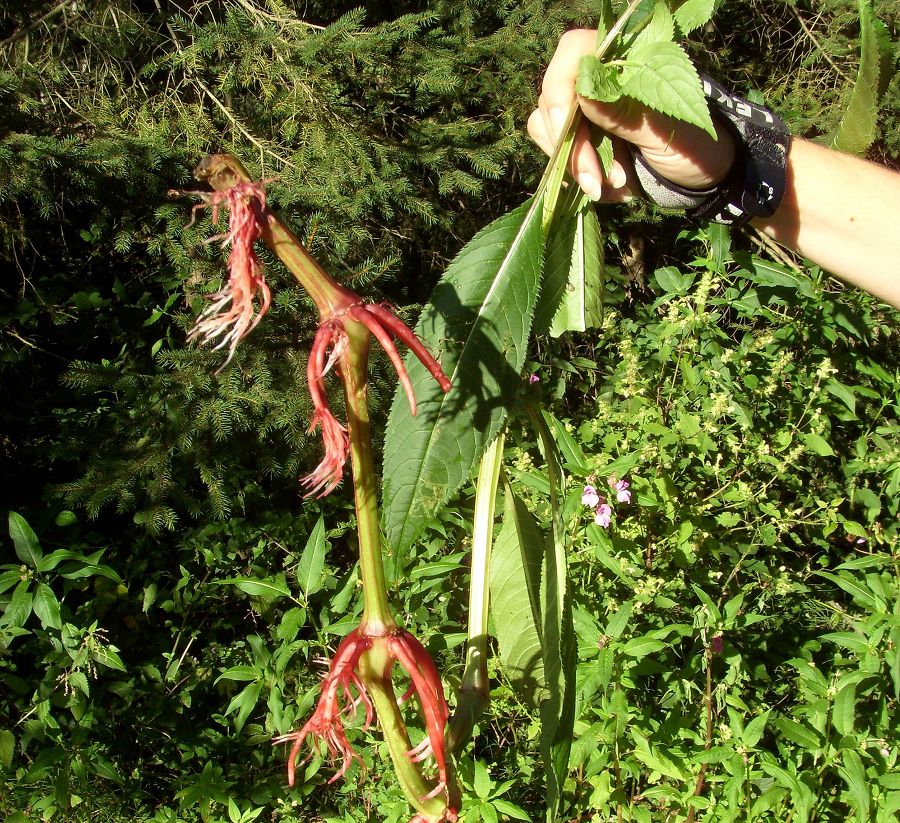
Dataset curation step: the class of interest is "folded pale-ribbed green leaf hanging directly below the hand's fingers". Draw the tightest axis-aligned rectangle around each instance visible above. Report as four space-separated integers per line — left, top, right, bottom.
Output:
548 197 604 337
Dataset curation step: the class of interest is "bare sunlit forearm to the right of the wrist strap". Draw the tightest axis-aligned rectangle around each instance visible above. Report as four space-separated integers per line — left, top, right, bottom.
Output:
754 139 900 308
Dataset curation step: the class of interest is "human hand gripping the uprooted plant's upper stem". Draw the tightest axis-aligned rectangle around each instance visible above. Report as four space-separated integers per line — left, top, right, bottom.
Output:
528 29 735 202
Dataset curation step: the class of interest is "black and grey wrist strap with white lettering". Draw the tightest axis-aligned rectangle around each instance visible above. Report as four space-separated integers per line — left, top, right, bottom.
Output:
633 76 791 226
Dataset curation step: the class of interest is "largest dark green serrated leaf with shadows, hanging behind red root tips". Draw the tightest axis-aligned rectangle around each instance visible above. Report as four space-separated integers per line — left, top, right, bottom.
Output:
383 200 542 551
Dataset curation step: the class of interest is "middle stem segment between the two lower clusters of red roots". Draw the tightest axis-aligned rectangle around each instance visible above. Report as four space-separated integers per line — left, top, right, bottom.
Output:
341 318 397 635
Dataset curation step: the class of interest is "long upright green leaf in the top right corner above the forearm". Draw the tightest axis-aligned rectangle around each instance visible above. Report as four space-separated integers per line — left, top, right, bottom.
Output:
831 0 893 155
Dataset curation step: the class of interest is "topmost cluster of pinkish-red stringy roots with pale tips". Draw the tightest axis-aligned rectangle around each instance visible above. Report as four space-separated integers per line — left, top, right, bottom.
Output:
187 183 272 371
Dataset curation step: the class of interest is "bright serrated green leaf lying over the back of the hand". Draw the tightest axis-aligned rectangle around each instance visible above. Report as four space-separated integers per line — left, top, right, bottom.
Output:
622 42 716 137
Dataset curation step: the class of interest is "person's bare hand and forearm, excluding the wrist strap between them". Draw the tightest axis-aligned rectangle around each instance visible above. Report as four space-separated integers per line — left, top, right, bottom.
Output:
528 30 900 308
